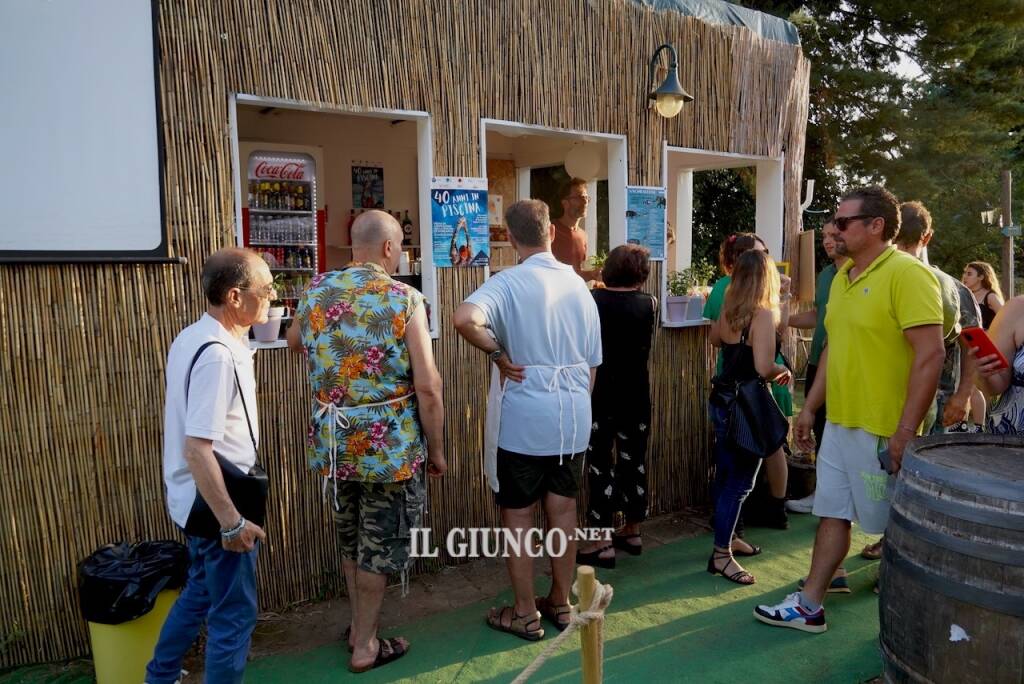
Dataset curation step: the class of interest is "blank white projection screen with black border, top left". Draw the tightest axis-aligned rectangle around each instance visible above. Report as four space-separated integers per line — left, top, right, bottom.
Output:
0 0 168 263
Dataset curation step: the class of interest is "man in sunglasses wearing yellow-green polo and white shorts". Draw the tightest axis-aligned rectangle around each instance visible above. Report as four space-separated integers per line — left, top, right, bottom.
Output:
754 186 945 633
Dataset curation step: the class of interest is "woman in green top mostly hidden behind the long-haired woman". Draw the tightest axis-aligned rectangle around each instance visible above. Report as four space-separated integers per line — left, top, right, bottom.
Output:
703 232 793 532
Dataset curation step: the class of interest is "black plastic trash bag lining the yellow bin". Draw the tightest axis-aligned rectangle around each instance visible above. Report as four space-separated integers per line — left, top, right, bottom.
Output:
78 541 188 625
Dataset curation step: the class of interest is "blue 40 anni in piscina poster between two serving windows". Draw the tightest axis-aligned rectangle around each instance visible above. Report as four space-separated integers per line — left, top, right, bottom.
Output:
430 176 490 267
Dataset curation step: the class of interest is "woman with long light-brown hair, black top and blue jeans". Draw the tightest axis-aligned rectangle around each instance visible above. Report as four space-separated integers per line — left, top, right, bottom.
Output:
708 250 791 585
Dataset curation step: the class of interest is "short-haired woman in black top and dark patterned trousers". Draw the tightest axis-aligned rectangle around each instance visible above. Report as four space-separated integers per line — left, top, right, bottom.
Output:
577 245 657 567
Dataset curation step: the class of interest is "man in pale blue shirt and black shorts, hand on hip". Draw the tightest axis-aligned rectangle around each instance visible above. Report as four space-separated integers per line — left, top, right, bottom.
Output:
455 200 601 641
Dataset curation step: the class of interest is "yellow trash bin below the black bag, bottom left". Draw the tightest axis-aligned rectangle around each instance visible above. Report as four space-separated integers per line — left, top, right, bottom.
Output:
88 589 181 684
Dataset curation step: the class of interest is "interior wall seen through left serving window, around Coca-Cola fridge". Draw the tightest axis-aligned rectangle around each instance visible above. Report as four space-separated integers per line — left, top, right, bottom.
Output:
238 105 421 260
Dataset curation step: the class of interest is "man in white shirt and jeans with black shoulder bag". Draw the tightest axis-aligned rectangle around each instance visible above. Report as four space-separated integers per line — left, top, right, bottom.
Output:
145 248 275 684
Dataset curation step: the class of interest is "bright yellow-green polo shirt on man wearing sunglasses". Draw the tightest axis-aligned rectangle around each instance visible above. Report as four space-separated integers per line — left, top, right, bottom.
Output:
825 247 942 437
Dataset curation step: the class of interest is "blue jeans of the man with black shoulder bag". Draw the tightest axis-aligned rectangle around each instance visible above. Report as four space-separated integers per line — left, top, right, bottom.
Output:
145 537 259 684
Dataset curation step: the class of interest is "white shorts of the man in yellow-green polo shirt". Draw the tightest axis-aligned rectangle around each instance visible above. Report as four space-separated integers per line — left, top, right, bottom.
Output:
813 422 895 535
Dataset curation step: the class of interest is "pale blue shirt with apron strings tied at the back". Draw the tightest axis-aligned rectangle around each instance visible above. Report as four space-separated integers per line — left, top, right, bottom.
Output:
466 252 601 456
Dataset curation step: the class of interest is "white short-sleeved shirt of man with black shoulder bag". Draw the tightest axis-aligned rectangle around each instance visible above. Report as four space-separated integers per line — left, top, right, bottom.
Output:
164 313 259 527
